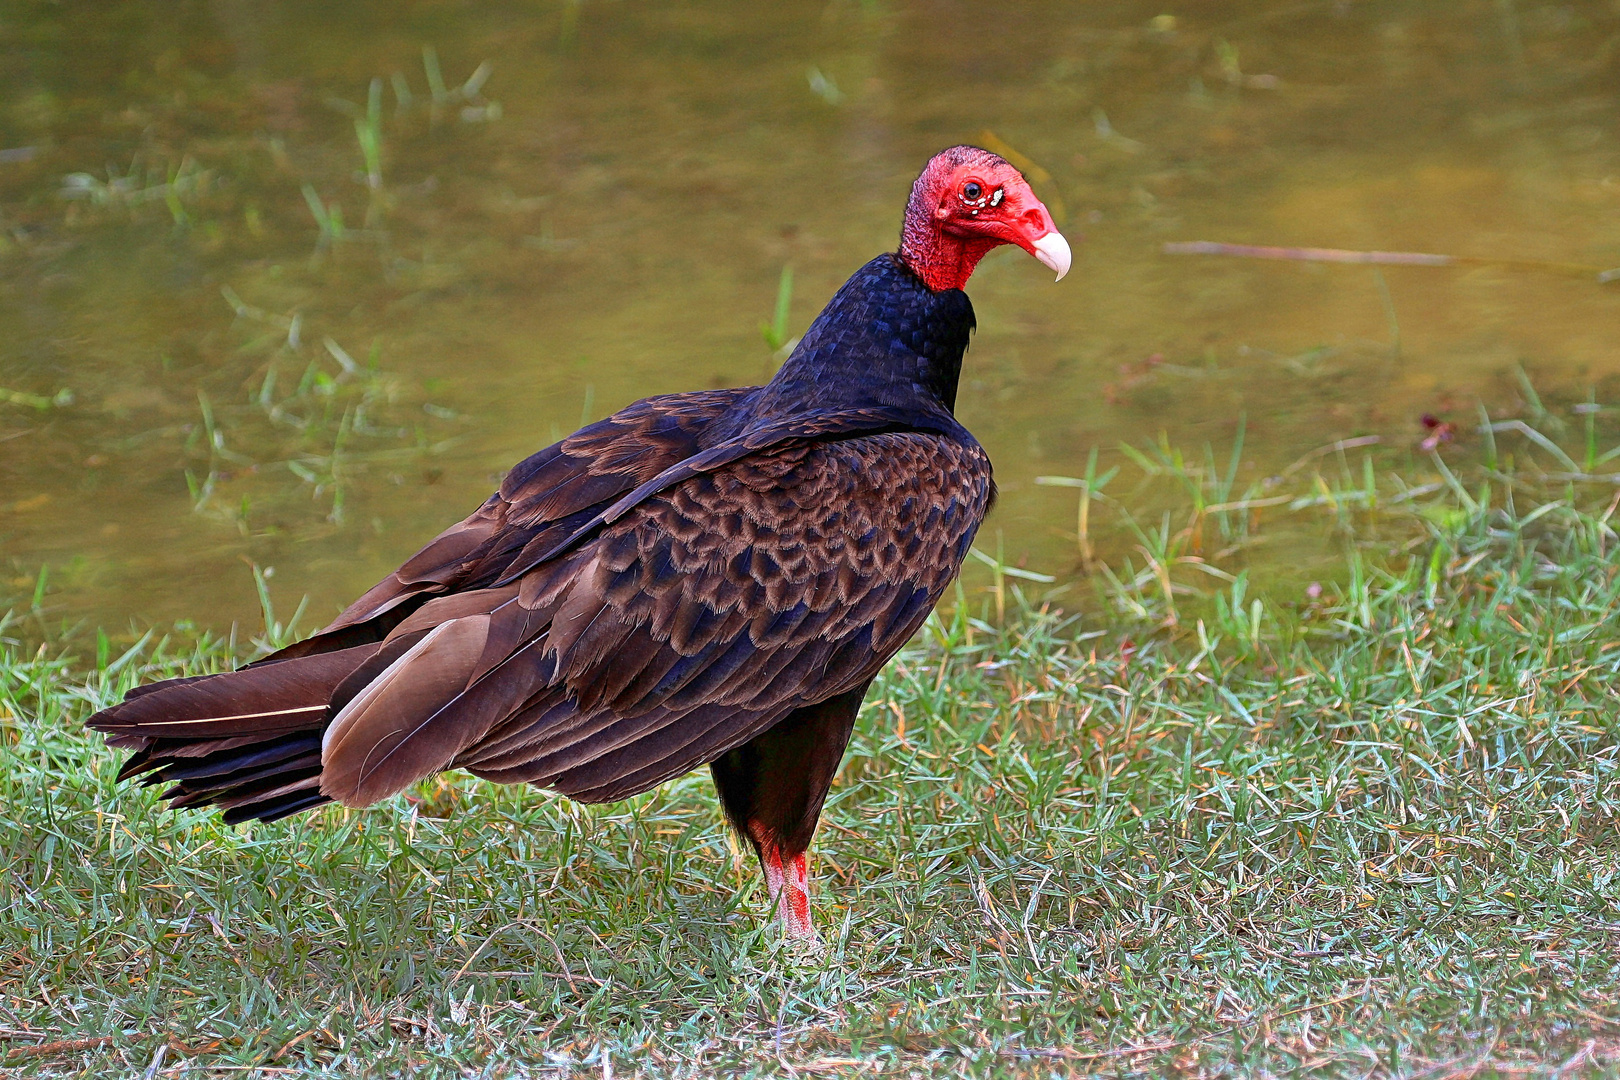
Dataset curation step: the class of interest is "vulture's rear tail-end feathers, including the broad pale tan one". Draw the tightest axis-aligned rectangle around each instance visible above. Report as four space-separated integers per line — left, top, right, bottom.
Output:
87 585 556 821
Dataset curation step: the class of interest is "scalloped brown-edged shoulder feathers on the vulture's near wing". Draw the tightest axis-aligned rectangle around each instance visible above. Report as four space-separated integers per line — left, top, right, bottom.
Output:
576 431 993 651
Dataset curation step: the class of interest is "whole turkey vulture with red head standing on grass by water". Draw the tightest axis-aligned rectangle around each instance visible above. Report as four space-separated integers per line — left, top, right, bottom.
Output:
89 146 1069 938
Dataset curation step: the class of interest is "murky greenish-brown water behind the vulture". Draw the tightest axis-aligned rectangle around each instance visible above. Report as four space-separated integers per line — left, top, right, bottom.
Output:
0 0 1620 628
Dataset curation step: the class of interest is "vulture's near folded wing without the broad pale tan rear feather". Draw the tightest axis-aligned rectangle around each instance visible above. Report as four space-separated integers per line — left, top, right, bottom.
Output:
454 432 990 801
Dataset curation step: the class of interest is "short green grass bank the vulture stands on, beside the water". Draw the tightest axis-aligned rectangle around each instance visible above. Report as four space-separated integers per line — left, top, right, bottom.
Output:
9 426 1620 1077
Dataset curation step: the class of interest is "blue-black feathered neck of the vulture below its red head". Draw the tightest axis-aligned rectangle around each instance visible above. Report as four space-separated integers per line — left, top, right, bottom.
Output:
753 254 974 416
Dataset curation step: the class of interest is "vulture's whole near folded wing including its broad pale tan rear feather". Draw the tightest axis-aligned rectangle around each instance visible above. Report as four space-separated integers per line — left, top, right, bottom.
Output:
309 432 990 805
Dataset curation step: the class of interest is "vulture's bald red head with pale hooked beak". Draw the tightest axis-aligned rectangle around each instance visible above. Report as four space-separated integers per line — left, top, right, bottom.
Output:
901 146 1069 291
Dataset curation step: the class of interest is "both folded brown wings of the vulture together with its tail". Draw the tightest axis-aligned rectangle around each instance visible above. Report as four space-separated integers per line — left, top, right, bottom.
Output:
91 390 991 819
